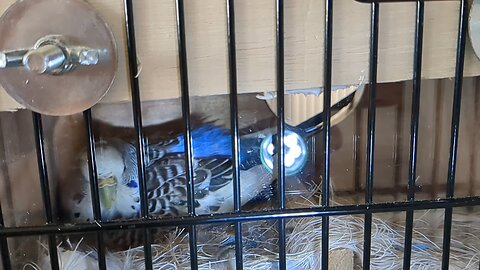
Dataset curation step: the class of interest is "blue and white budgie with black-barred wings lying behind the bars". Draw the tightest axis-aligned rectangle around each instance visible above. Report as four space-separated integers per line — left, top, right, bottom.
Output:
61 124 273 223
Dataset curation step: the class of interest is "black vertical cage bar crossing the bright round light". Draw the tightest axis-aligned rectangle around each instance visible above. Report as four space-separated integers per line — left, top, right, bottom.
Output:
275 0 287 270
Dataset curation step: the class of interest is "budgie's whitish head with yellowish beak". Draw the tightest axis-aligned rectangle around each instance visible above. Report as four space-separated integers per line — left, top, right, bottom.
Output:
82 141 125 210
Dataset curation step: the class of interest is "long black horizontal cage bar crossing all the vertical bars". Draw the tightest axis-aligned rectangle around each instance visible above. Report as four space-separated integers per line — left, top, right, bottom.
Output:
0 196 480 237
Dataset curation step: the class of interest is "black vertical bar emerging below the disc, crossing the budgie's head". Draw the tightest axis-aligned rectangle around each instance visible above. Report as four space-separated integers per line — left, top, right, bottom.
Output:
83 109 107 269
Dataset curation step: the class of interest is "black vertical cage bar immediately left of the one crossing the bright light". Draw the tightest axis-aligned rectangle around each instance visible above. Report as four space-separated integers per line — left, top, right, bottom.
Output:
227 0 243 269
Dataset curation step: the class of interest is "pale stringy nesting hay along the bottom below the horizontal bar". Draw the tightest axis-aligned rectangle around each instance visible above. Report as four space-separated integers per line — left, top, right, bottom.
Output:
25 206 480 270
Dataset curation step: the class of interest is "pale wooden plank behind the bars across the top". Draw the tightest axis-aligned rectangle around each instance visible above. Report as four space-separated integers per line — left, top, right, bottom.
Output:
0 0 480 110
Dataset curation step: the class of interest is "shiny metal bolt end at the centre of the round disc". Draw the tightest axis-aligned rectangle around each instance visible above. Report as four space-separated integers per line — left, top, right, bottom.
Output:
23 45 66 74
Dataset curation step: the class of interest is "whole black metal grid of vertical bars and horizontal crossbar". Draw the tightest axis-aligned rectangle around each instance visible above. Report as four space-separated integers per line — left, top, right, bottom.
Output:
0 0 474 269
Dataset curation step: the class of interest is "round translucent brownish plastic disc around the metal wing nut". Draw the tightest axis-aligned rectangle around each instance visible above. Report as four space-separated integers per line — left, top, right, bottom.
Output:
0 0 117 116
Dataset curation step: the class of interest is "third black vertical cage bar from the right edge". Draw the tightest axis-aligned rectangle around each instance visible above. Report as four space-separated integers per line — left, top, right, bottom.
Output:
363 1 380 270
